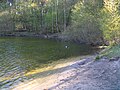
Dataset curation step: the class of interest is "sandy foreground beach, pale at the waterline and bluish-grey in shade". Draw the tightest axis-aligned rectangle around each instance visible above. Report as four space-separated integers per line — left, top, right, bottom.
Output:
12 57 120 90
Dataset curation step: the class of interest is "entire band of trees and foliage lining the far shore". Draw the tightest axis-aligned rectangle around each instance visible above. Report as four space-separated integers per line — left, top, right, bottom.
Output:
0 0 120 44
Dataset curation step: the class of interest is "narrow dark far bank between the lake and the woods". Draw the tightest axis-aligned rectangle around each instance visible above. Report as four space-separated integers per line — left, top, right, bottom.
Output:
0 32 105 47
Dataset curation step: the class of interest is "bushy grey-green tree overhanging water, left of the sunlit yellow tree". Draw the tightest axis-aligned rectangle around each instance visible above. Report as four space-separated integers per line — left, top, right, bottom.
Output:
65 1 102 44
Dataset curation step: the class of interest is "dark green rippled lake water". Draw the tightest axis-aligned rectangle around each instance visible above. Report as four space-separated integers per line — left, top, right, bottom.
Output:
0 37 96 90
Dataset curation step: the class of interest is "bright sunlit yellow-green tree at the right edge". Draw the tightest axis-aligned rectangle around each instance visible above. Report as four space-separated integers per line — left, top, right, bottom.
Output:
101 0 120 44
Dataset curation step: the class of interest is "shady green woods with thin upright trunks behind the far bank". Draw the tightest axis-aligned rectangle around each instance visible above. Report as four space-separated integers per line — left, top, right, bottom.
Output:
1 0 74 33
